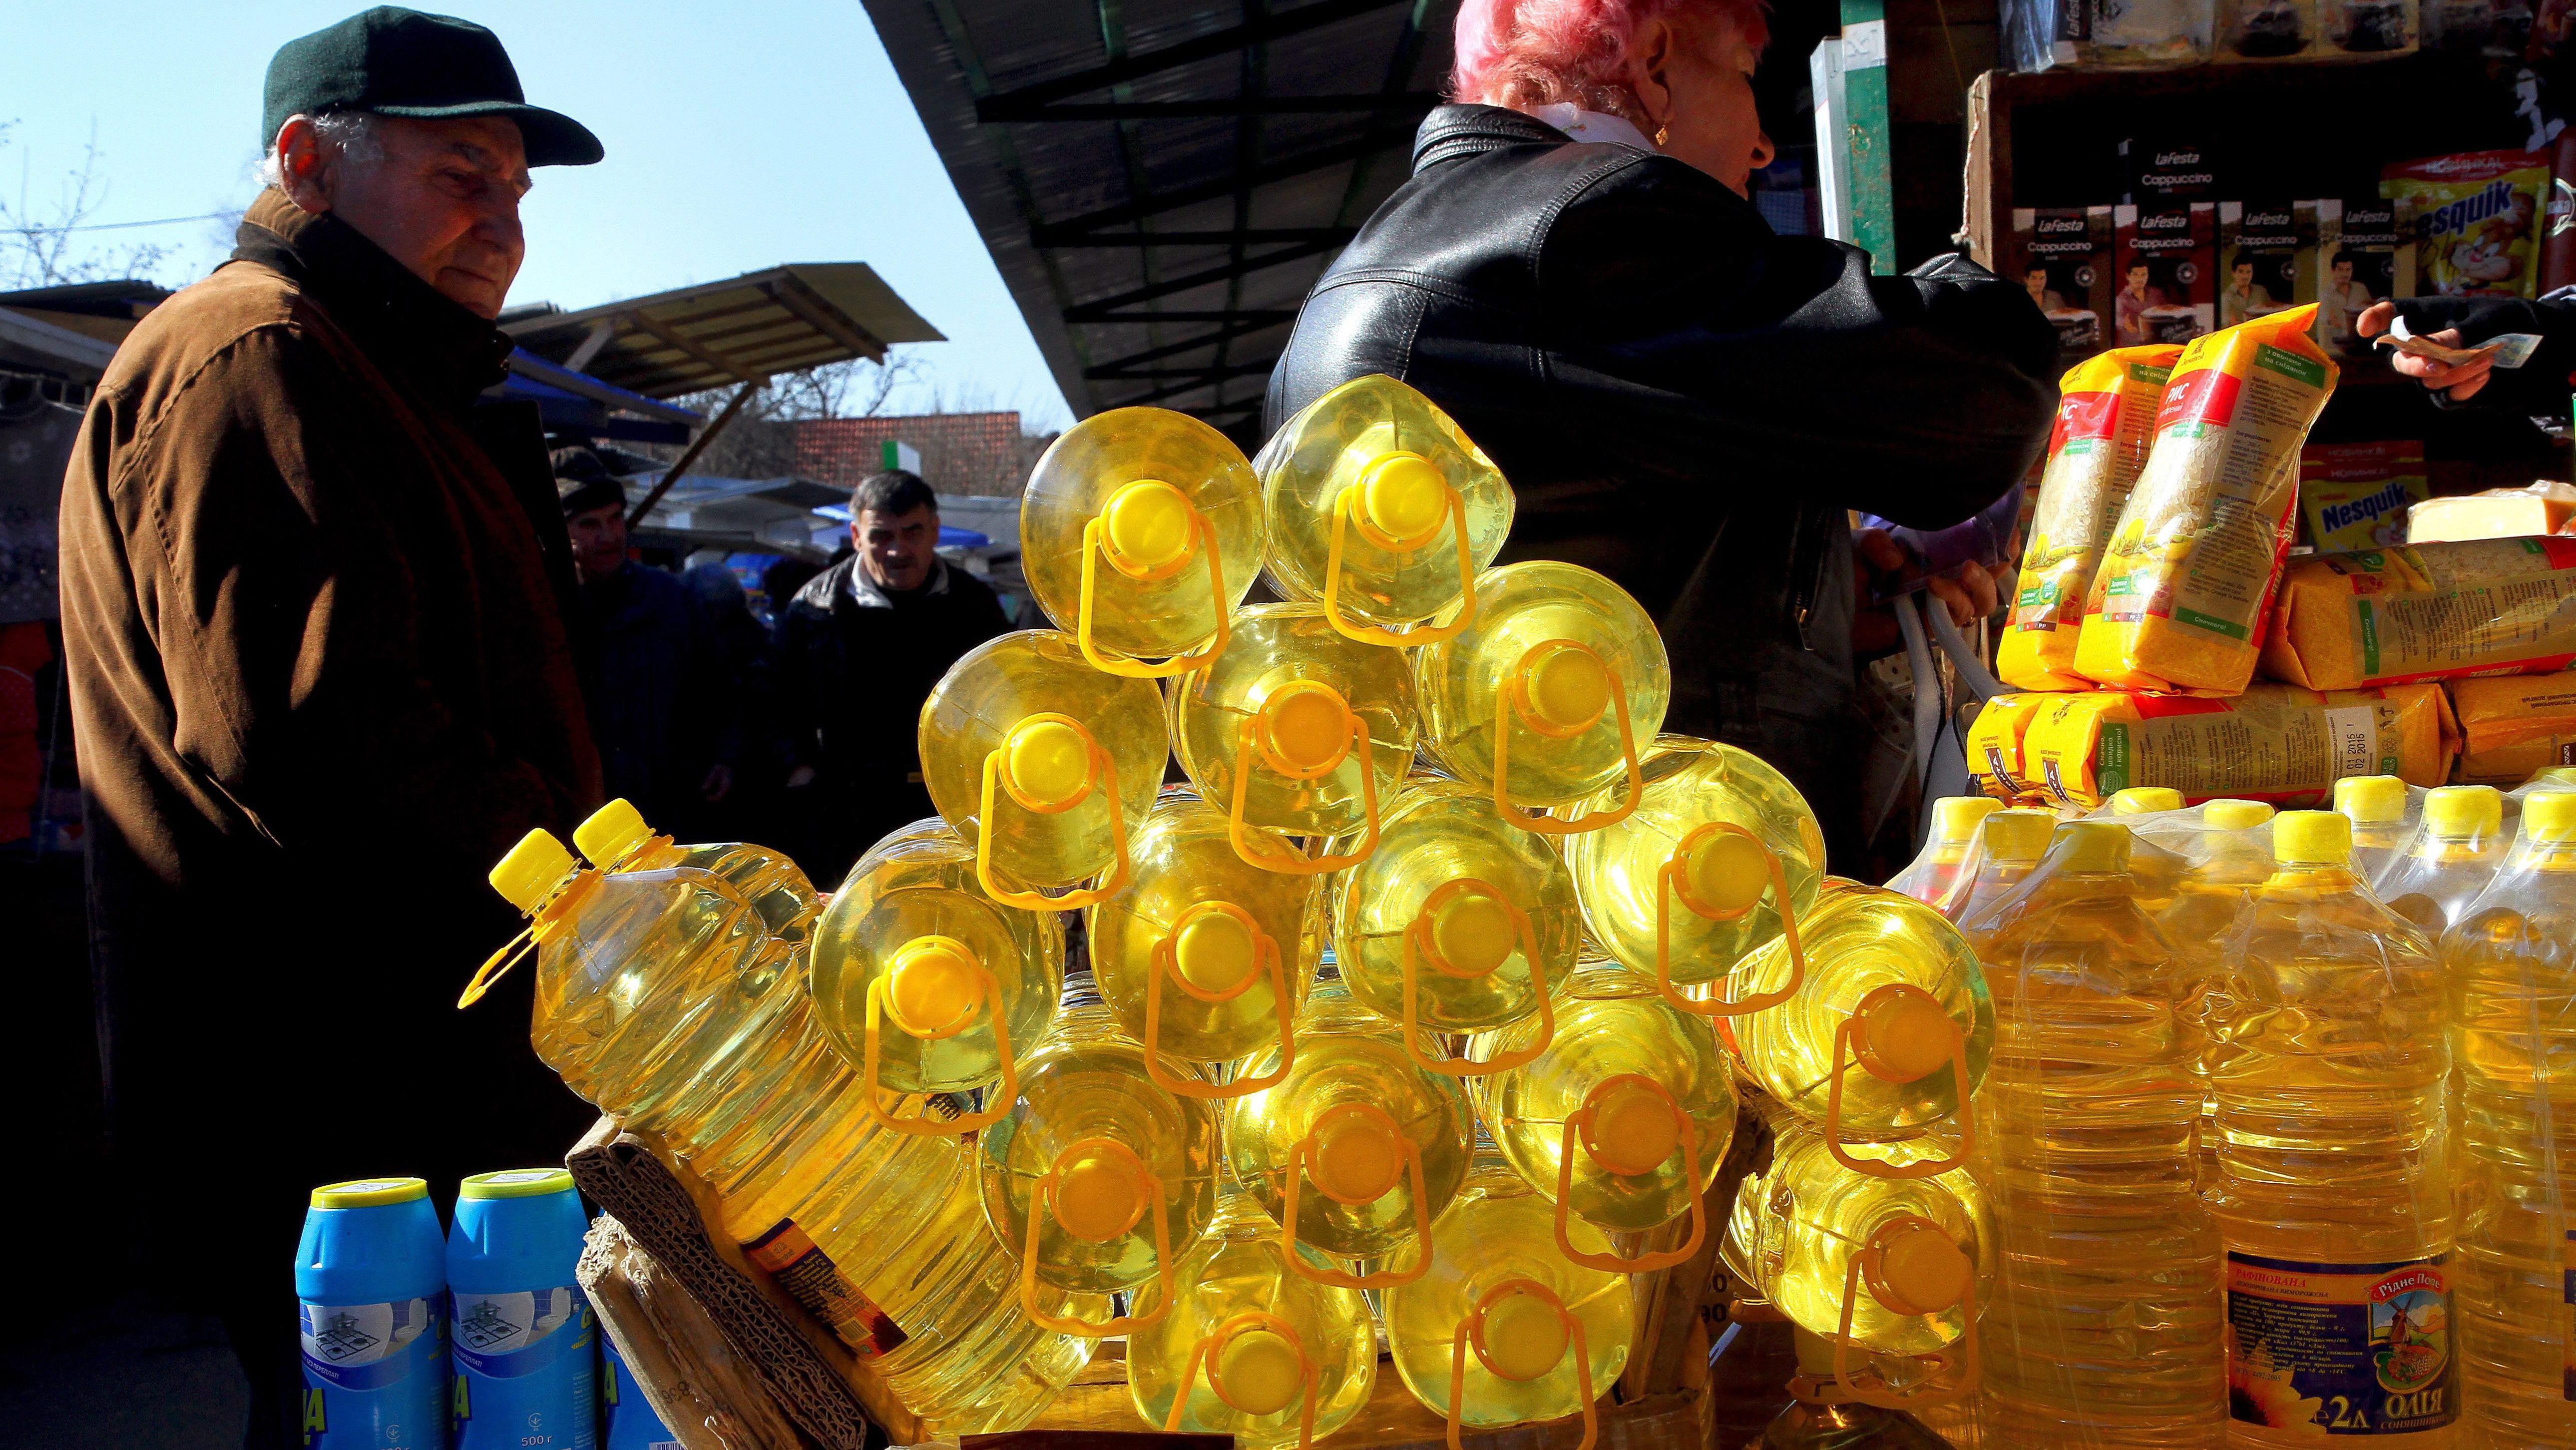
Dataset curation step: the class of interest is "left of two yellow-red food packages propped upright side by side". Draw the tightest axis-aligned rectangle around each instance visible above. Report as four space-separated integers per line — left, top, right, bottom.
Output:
1994 345 2182 690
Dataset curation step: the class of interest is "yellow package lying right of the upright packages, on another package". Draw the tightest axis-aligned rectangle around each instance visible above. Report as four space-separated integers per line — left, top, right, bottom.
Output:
2262 538 2576 690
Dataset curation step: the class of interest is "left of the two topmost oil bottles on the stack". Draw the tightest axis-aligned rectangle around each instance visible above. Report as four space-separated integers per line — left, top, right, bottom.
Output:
1020 407 1270 659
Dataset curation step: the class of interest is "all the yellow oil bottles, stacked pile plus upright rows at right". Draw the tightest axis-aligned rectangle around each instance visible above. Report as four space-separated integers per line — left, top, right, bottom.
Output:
448 376 2576 1450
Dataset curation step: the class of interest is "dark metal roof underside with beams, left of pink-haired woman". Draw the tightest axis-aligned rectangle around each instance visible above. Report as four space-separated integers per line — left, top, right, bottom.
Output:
865 0 1458 433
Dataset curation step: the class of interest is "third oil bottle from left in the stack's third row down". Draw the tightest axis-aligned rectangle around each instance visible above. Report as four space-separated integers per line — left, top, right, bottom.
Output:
1334 778 1582 1076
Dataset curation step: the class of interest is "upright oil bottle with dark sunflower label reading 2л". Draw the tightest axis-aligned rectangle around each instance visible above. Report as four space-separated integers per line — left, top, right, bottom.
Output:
2205 811 2460 1450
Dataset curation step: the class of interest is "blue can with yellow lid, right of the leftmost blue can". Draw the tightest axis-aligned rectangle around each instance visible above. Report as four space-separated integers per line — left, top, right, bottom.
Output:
448 1169 600 1450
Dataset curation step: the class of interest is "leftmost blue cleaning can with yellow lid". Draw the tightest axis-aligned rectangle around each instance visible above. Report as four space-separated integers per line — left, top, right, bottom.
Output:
296 1177 448 1450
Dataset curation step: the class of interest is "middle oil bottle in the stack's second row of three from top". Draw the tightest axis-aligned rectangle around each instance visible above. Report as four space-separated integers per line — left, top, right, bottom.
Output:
1172 605 1414 850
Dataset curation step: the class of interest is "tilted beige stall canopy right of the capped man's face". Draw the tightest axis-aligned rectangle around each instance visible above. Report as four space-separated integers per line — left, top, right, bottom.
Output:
502 263 945 397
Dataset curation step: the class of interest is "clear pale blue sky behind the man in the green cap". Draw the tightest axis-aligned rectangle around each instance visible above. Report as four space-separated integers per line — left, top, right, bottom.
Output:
0 0 1072 428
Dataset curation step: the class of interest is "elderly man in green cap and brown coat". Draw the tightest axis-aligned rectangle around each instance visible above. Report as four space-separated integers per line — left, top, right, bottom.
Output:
62 7 600 1445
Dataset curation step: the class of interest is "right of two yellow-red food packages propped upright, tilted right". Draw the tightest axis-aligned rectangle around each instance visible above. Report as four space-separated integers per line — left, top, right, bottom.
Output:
2076 304 2336 695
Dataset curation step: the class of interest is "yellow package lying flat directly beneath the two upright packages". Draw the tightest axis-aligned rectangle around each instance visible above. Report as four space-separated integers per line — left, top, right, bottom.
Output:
2022 685 2460 809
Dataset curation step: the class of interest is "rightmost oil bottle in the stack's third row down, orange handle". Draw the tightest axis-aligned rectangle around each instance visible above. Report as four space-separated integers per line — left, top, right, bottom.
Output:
1566 734 1824 981
